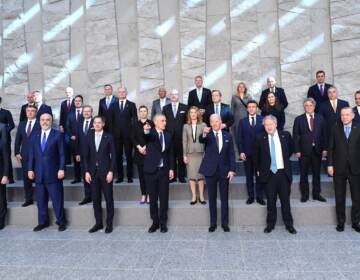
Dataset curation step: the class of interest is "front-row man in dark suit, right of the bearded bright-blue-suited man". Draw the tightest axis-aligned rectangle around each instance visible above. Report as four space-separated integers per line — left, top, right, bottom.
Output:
83 116 115 233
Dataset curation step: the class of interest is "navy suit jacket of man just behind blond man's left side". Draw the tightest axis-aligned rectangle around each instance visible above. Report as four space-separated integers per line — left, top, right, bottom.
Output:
236 115 265 156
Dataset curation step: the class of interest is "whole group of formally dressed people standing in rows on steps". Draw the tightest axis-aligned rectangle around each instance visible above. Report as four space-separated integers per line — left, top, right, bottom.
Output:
0 71 360 234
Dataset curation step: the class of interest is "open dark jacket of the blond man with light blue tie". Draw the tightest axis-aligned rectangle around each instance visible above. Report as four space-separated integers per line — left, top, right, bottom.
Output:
253 130 293 183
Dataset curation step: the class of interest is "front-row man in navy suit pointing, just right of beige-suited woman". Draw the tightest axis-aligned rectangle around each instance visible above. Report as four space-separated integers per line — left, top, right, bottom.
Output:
199 114 236 232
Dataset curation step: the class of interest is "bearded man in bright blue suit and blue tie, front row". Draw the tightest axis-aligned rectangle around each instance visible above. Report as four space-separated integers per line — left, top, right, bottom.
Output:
28 113 66 231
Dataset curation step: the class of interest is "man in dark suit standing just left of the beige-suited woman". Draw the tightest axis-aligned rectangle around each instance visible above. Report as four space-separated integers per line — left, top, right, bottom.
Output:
163 89 187 183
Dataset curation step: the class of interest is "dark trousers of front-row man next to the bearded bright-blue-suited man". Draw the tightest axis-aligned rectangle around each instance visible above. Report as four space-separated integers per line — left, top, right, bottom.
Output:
90 172 114 226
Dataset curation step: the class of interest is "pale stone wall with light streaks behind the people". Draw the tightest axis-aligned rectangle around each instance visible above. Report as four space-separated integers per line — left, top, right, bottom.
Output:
0 0 360 132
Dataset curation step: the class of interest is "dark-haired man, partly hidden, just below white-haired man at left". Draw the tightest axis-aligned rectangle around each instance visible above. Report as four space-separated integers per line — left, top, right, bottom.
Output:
66 95 83 184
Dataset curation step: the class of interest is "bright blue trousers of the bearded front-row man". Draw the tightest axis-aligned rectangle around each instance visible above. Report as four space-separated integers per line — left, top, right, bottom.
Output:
35 181 66 225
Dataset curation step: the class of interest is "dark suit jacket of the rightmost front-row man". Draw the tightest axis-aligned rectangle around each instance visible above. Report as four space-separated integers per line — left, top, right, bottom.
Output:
328 122 360 176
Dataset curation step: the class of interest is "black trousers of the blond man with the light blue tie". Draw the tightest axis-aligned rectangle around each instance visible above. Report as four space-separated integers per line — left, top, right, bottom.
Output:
266 169 293 227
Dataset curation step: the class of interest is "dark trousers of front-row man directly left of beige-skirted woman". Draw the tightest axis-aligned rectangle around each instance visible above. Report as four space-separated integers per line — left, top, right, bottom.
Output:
145 168 169 225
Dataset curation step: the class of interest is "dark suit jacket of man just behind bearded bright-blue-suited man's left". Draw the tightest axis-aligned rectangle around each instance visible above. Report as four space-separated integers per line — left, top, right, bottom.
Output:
14 120 40 163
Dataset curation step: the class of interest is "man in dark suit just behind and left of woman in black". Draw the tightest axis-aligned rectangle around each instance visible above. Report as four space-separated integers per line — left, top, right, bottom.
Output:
109 87 137 183
